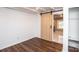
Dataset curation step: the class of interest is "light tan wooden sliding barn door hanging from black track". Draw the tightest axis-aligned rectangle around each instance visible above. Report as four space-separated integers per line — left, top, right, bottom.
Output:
41 12 52 41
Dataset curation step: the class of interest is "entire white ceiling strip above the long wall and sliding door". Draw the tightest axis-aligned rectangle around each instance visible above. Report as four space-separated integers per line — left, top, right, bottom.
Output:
7 7 63 13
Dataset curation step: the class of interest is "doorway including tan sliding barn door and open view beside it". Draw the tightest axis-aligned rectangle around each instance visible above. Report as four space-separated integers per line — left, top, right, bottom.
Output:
41 12 63 43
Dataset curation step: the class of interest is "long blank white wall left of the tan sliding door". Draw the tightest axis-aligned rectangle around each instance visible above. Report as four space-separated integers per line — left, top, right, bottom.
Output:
0 8 40 49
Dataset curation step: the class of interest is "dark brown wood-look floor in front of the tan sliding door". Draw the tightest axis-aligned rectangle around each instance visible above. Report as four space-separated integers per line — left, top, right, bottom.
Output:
0 37 63 52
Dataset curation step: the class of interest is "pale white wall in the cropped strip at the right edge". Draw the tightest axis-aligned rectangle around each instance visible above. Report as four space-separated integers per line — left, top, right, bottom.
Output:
69 8 79 41
